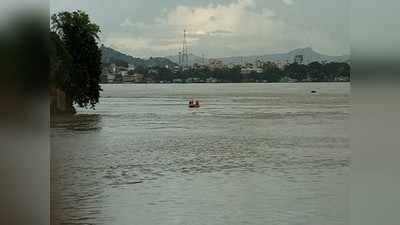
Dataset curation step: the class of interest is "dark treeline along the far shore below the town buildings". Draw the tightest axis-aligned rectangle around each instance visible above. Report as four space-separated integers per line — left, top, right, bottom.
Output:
133 62 350 83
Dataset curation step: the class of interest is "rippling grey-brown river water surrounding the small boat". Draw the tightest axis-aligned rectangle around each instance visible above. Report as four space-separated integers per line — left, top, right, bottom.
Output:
51 83 350 225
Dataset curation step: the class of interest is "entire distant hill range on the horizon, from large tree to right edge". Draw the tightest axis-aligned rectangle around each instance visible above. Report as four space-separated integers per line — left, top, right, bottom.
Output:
101 46 350 67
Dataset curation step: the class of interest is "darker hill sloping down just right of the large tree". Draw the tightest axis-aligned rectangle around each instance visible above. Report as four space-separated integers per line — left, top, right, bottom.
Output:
100 46 177 67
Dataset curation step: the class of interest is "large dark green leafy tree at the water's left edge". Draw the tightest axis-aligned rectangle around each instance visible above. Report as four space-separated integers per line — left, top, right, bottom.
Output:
51 10 102 108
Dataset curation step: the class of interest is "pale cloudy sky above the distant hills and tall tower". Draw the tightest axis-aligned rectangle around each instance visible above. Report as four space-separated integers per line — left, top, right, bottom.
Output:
50 0 350 57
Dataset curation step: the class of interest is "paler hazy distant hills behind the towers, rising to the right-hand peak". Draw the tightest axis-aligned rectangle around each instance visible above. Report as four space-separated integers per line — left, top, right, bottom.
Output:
166 48 350 65
